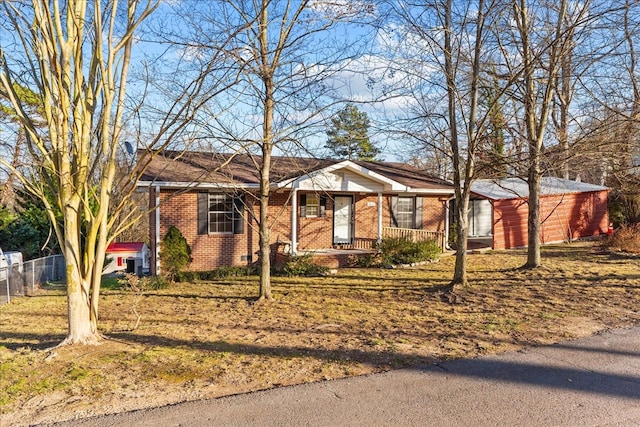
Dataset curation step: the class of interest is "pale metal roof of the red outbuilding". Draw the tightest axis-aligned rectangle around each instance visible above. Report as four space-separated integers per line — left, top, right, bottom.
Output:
471 177 609 200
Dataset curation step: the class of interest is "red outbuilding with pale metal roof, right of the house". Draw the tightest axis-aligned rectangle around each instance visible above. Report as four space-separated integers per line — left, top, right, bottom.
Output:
468 177 609 249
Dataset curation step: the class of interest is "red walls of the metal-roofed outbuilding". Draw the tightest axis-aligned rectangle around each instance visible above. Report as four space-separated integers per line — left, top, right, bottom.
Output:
493 191 609 249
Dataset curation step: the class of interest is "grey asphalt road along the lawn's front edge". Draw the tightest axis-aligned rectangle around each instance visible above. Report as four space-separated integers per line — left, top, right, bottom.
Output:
55 327 640 427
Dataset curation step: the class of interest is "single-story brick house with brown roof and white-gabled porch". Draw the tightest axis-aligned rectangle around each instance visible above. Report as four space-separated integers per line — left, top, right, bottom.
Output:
138 151 454 274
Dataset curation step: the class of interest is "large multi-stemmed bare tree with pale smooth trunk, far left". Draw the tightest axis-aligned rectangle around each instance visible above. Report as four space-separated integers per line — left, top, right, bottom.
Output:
0 0 230 344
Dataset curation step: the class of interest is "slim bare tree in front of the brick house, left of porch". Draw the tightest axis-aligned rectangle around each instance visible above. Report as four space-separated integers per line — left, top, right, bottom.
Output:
165 0 372 300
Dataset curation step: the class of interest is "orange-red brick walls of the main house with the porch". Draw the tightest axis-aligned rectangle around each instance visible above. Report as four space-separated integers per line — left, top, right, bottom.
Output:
149 188 445 272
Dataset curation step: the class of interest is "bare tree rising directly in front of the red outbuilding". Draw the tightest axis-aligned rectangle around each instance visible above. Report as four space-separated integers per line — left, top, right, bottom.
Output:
503 0 590 268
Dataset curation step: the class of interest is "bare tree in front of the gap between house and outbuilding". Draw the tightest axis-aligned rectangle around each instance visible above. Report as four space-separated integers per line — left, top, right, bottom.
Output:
384 0 497 290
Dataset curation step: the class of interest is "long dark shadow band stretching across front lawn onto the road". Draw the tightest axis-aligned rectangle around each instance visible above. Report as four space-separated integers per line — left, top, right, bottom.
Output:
0 326 640 399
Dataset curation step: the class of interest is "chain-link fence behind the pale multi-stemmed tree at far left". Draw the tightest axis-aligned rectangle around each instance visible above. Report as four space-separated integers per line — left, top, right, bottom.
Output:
0 255 65 304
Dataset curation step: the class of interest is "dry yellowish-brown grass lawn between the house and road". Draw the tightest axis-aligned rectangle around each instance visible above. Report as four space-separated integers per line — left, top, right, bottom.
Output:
0 243 640 426
